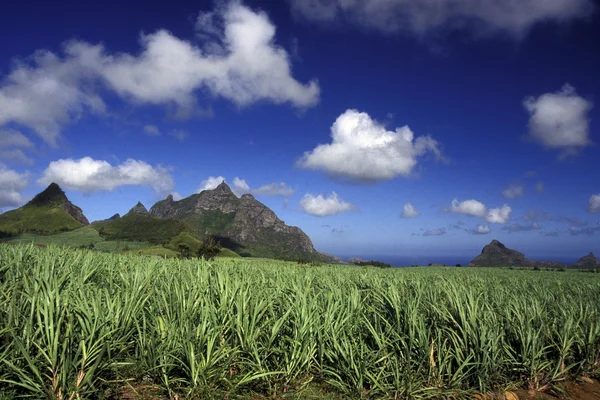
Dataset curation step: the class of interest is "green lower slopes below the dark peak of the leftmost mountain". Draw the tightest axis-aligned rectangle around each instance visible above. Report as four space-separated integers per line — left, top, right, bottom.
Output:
0 205 82 237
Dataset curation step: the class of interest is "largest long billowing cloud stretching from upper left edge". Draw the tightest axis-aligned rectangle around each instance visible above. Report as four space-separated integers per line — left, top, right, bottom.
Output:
0 1 320 146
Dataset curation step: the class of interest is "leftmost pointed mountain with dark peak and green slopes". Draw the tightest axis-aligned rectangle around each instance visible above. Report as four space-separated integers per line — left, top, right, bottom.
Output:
0 182 89 236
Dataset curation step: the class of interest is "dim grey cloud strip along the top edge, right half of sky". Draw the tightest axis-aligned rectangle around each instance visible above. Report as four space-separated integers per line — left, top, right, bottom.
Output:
289 0 593 38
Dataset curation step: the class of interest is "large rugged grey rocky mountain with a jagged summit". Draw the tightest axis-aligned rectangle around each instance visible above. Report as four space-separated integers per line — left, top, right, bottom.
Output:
150 182 331 261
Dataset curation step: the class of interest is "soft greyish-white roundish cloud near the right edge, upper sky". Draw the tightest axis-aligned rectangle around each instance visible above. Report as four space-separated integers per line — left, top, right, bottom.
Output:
523 84 592 156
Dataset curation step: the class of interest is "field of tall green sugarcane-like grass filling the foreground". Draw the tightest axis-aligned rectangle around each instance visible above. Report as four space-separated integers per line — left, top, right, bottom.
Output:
0 246 600 399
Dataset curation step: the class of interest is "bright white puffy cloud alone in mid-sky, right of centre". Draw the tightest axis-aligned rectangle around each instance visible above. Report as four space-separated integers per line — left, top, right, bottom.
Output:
298 110 441 181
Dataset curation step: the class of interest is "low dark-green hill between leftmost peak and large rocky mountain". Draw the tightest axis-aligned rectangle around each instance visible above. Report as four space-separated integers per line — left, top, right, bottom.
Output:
92 214 188 244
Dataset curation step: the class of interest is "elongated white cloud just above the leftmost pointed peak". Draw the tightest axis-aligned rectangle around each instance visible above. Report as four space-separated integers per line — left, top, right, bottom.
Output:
38 157 174 195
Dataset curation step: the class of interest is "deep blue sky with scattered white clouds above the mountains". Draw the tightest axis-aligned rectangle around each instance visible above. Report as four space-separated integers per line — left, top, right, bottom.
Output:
0 0 600 259
